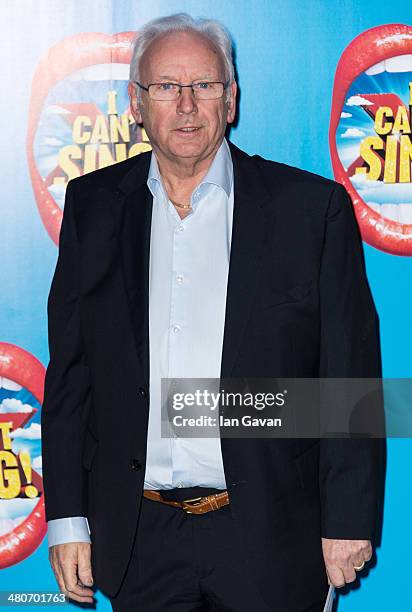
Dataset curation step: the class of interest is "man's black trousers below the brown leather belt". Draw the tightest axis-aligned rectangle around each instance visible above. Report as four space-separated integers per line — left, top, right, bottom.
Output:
110 487 270 612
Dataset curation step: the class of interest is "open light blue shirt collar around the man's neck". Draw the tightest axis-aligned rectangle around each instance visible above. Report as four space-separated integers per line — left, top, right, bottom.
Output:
147 138 233 199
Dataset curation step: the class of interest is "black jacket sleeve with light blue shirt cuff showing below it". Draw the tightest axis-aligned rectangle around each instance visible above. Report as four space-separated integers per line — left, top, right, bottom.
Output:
41 182 90 521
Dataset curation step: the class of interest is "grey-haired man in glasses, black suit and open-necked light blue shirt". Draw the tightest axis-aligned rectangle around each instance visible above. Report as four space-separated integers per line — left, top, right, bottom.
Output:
42 10 382 612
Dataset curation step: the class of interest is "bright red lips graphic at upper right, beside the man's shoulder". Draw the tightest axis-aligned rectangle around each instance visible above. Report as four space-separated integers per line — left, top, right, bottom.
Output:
329 24 412 256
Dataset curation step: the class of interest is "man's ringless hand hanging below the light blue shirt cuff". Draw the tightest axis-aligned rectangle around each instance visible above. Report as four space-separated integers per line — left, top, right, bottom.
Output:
49 542 94 603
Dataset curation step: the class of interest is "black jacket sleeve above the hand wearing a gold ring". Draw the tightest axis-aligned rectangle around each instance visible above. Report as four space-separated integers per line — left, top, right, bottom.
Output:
320 185 384 539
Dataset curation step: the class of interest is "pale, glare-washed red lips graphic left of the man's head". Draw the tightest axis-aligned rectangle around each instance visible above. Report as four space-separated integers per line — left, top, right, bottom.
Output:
26 32 143 244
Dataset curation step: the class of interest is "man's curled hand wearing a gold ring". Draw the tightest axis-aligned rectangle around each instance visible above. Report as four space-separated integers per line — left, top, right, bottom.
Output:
322 538 372 587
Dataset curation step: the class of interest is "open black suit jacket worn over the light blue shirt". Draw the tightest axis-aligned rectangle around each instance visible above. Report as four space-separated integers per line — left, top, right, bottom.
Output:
42 144 383 612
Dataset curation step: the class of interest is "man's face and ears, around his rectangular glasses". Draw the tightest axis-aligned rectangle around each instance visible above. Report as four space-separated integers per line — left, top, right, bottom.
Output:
129 32 236 163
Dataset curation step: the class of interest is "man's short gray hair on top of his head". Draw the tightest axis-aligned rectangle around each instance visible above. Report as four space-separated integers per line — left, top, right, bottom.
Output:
129 13 235 91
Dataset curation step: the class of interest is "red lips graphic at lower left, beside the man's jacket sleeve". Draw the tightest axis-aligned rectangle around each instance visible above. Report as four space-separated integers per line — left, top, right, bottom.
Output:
0 342 47 569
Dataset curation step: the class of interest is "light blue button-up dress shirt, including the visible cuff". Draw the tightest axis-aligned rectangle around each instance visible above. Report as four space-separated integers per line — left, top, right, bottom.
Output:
48 139 233 547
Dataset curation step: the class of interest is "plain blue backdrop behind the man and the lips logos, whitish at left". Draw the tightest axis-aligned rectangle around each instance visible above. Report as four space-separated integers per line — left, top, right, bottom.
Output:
0 0 412 612
